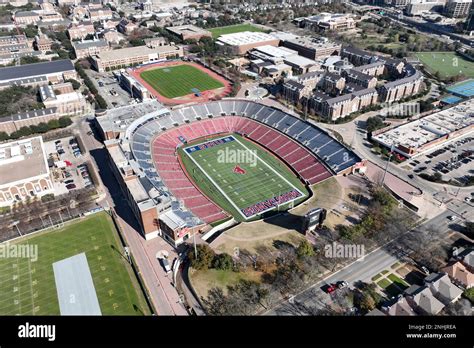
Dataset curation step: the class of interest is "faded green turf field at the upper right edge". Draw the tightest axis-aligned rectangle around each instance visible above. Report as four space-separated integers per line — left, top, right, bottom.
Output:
416 52 474 78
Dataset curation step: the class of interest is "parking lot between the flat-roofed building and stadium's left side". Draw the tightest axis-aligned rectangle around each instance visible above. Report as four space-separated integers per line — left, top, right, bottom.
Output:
45 137 93 195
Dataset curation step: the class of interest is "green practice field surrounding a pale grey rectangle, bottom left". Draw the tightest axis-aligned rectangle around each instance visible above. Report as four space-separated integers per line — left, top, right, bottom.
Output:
0 213 149 315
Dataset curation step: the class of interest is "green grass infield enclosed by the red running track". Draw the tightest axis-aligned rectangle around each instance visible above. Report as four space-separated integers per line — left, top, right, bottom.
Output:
140 64 224 98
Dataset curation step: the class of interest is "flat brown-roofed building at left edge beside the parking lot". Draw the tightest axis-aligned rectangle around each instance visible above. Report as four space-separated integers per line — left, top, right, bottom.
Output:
0 137 54 207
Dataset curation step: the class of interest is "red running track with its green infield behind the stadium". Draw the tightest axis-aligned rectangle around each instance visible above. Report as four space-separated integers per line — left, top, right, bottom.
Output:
129 61 232 105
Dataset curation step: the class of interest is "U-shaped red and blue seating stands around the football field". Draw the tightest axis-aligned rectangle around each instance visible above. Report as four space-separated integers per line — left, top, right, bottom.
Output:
129 99 362 223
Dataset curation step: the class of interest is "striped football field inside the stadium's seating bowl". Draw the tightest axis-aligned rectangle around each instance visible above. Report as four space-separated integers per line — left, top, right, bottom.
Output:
179 134 308 221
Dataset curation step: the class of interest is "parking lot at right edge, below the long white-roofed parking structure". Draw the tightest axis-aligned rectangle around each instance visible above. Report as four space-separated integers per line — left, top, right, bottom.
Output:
408 136 474 184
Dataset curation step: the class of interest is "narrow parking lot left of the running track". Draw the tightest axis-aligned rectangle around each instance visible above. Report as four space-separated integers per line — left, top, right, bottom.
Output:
87 70 136 107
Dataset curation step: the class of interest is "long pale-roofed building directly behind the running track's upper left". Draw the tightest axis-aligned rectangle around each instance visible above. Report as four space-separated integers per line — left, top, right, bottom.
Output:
92 45 183 72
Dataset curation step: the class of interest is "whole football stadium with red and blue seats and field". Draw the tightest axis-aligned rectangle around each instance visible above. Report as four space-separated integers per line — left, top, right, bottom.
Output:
98 98 365 245
